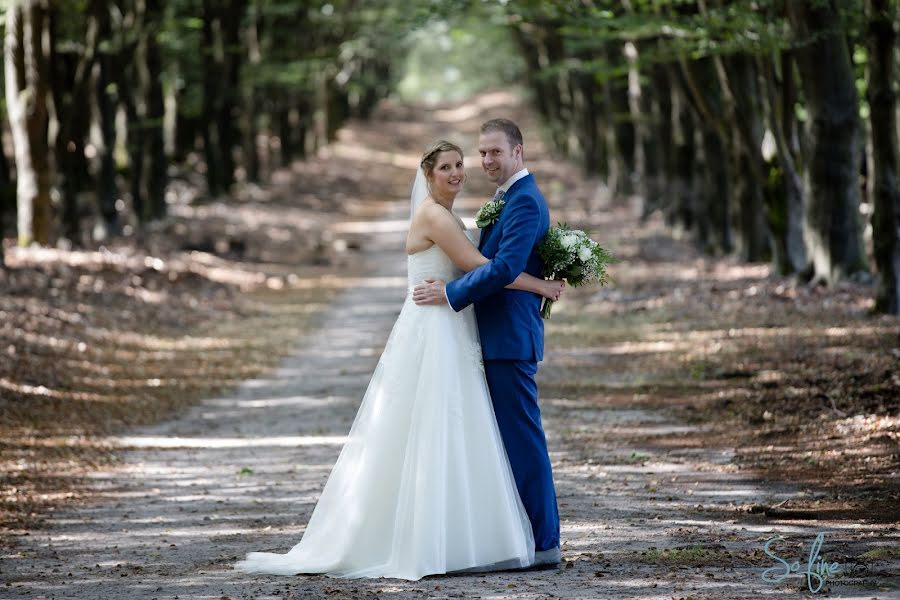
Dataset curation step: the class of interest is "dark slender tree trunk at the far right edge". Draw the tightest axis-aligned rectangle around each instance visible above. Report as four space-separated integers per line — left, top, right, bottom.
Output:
866 0 900 315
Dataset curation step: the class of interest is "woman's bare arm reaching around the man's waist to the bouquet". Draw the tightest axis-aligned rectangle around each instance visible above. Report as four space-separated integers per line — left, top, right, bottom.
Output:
422 204 565 299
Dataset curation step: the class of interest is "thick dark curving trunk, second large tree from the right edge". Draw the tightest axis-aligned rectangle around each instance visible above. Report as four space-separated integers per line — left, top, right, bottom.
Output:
786 0 866 284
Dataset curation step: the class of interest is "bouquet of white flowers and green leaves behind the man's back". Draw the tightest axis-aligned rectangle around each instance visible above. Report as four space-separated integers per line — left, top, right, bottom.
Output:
537 223 613 319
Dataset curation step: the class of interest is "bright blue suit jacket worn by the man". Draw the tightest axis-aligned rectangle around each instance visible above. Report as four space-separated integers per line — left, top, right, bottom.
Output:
447 174 550 361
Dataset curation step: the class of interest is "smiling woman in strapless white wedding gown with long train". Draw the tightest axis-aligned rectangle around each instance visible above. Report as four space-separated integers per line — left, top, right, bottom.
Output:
236 141 563 580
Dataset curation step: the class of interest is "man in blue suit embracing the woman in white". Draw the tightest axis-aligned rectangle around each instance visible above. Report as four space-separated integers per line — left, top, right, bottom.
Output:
413 119 560 568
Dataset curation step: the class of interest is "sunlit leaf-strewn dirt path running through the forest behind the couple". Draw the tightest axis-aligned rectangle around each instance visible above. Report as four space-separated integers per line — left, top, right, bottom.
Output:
0 94 900 600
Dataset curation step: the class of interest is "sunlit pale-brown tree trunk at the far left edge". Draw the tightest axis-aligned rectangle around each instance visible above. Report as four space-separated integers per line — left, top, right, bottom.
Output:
4 0 50 246
